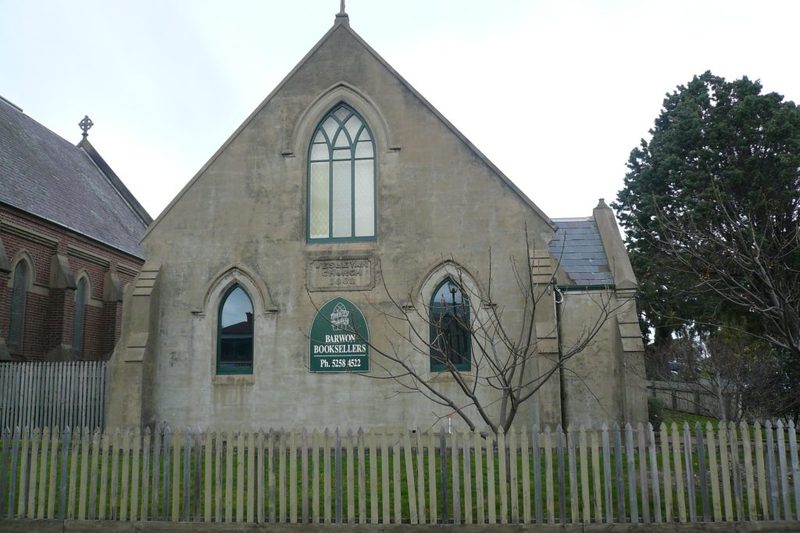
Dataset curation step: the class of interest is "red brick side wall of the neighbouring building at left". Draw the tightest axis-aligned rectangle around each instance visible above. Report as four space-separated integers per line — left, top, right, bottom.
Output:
0 205 143 360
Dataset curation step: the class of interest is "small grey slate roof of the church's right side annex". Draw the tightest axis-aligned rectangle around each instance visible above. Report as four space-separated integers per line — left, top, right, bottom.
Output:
549 217 614 285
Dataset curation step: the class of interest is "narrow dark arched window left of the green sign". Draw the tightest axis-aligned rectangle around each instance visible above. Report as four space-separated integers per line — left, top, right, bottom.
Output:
217 285 253 374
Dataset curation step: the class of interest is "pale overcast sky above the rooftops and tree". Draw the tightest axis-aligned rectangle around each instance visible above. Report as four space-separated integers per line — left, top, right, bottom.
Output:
0 0 800 217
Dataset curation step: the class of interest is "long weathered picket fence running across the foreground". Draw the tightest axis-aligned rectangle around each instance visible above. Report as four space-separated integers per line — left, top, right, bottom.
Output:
0 421 800 524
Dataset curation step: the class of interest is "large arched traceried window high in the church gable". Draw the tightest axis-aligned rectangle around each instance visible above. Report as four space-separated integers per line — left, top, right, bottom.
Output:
308 103 375 242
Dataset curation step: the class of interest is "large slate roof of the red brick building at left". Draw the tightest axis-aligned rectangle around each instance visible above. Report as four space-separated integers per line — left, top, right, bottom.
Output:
0 98 152 258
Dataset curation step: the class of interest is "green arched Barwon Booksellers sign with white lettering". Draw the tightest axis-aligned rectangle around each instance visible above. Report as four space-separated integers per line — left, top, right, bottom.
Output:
308 298 369 372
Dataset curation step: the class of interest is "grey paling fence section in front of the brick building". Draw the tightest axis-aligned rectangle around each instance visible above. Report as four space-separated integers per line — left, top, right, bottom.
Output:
0 361 106 429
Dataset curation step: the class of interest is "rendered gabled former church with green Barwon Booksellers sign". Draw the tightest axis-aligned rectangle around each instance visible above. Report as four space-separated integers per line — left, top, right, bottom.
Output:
107 8 647 430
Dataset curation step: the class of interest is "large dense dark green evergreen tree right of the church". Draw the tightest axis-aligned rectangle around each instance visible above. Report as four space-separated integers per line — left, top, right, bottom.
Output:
613 72 800 356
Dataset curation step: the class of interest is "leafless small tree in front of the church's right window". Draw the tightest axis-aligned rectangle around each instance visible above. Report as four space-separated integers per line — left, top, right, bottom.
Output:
312 230 626 432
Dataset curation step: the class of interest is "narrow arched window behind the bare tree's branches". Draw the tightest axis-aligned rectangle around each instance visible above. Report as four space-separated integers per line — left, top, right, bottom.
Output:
430 278 472 371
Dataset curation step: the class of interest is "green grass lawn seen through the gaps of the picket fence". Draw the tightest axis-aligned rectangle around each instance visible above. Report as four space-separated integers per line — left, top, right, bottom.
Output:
0 420 793 522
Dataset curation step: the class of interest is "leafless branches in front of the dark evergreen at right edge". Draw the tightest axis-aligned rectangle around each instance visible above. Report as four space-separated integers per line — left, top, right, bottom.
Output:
659 188 800 358
